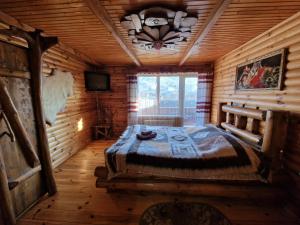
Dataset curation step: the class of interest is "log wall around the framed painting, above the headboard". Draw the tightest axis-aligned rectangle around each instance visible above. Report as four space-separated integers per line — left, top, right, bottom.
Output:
212 12 300 206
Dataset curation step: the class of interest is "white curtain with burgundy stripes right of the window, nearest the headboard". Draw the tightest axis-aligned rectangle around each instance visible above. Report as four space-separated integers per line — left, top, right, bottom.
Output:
196 73 213 126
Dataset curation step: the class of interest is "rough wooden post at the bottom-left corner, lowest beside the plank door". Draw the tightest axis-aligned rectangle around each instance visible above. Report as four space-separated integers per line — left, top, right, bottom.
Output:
0 149 16 225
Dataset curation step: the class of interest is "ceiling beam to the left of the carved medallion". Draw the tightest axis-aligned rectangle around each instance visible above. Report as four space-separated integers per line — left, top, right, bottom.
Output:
86 0 141 66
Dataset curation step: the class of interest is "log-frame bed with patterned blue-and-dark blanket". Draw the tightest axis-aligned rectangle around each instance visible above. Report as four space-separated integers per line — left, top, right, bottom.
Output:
95 103 287 196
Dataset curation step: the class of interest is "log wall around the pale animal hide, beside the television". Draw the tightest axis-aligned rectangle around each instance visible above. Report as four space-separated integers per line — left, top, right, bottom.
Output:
43 47 96 167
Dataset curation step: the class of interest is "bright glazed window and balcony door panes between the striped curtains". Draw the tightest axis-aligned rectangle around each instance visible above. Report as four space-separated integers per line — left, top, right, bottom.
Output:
138 76 198 125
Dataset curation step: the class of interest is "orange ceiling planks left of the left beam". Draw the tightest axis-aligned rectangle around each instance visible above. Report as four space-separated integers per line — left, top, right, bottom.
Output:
0 0 134 65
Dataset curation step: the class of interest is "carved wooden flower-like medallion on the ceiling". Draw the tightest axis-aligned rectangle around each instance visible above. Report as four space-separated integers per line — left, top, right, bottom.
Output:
121 7 197 50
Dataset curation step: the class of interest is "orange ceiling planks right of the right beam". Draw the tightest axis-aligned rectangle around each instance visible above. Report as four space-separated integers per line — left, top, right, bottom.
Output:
186 0 300 64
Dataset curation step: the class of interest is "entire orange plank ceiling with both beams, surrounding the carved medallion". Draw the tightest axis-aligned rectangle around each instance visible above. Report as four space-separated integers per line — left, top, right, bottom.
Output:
0 0 300 65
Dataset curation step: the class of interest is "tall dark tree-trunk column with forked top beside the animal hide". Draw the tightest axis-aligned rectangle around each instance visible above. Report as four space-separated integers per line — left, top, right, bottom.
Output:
28 30 58 195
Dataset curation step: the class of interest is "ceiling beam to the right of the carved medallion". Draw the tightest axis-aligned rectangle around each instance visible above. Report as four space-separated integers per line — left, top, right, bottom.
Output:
179 0 231 66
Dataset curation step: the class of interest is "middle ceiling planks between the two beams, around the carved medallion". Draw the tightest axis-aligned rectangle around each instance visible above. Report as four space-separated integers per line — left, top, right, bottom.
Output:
100 0 218 65
